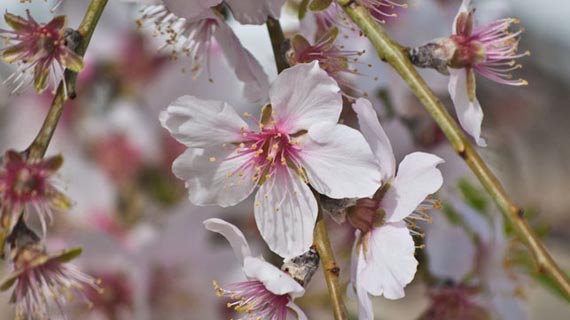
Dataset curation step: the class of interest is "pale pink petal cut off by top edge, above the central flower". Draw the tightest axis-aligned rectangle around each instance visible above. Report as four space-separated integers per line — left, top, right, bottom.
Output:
222 0 285 24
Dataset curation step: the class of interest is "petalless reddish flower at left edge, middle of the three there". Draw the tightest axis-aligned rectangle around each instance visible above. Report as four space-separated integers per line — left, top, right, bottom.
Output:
0 150 71 234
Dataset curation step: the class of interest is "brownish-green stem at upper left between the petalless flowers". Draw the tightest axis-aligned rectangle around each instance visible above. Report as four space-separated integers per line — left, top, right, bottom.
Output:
27 0 108 159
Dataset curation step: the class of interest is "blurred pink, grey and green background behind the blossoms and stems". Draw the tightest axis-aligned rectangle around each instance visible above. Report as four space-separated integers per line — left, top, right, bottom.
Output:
0 0 570 320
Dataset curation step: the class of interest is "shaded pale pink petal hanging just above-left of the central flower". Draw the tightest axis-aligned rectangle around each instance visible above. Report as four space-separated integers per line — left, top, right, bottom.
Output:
214 23 269 102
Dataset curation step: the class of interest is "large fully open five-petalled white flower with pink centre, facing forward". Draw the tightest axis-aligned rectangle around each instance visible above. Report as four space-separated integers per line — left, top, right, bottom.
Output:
160 62 380 258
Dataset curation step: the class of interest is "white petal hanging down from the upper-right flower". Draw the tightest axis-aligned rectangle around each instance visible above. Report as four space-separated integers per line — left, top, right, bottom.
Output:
448 68 487 147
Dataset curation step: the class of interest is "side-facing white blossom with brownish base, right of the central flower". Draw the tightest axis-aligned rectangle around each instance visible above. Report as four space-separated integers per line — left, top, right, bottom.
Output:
348 98 443 320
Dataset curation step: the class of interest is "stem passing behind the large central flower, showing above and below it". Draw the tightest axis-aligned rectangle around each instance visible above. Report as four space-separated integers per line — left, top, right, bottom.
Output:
267 17 348 320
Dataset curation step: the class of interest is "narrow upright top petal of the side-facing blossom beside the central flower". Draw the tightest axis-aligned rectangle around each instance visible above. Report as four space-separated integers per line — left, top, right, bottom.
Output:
352 98 396 182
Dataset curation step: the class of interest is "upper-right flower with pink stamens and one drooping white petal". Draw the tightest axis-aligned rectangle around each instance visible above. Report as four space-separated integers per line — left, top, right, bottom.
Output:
449 0 529 147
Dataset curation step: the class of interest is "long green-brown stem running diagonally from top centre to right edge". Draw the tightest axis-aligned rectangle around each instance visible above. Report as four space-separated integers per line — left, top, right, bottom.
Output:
336 0 570 298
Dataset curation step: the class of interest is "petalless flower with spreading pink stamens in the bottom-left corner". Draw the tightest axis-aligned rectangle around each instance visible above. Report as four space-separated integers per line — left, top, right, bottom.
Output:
0 243 101 319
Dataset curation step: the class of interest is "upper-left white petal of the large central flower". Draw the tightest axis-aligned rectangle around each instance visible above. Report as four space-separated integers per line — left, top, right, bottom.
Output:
160 96 248 148
